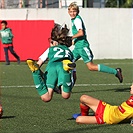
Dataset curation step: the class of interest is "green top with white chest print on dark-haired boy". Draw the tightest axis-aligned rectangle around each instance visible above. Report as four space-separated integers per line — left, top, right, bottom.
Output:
0 28 13 44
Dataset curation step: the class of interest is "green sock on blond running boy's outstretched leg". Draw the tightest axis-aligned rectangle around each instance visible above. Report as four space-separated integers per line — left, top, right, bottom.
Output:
98 64 117 75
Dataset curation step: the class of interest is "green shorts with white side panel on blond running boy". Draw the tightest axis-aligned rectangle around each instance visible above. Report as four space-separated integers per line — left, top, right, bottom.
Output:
72 46 93 63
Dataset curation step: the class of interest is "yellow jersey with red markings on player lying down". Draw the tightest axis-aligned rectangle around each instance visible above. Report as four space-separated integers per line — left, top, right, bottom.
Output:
103 96 133 124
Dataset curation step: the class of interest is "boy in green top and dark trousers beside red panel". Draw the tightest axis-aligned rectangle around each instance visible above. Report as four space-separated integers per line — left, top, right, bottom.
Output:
0 20 20 65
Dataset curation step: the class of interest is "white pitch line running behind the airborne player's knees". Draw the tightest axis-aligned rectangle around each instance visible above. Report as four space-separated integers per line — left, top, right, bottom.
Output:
0 83 132 88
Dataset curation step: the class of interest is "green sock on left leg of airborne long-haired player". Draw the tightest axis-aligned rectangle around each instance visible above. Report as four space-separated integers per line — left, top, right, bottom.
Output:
32 70 48 96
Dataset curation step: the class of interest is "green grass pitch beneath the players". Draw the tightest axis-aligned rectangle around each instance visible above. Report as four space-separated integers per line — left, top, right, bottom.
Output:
0 59 133 133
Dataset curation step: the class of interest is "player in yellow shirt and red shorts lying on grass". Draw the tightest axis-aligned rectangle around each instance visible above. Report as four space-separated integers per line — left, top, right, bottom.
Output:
73 85 133 124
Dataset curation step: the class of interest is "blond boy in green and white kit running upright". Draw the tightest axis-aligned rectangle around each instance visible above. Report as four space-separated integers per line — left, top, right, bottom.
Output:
68 2 123 83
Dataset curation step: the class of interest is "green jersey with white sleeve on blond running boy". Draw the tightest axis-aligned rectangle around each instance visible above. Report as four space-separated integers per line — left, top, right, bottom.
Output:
71 15 89 48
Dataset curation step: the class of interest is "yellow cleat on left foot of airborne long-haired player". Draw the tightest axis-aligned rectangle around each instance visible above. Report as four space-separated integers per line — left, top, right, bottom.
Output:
26 59 39 72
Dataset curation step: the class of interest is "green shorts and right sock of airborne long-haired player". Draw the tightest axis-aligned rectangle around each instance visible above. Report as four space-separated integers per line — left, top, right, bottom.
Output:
44 62 72 93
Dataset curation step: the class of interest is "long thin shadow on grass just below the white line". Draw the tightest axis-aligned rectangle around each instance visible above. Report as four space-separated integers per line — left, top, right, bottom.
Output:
72 88 130 93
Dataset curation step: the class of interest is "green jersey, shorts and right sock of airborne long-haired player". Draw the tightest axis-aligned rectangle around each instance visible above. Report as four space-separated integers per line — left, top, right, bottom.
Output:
44 44 73 93
